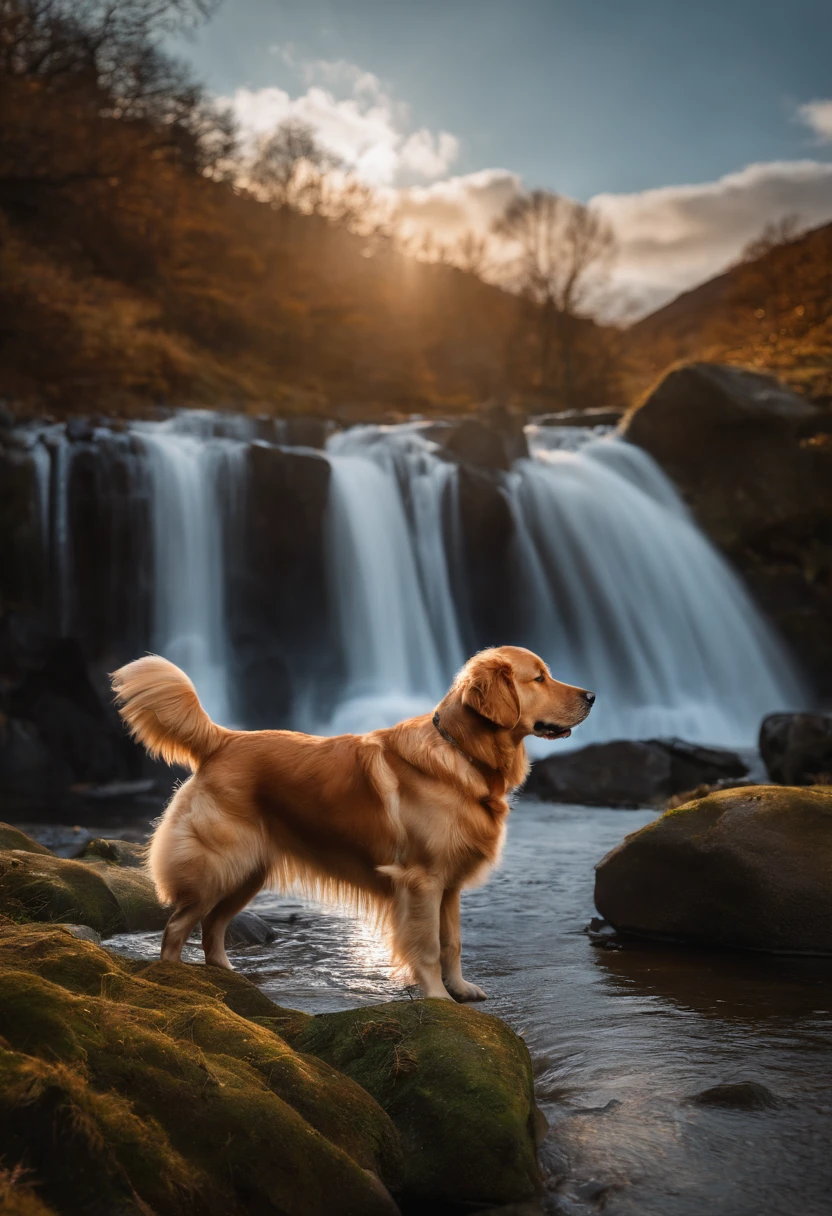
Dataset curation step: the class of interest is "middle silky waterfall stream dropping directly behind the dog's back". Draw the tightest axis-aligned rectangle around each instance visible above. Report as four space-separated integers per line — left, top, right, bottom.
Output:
327 427 462 732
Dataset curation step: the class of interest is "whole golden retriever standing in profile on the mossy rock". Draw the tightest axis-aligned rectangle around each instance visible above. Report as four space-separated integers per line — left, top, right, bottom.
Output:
112 646 595 1001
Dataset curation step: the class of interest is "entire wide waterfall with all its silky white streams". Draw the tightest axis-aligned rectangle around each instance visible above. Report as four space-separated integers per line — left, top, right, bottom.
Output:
21 411 806 755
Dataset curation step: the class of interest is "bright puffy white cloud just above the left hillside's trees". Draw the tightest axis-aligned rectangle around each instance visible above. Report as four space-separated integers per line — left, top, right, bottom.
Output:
220 54 460 186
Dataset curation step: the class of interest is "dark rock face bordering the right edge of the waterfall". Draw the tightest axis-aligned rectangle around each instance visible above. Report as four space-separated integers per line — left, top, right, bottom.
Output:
623 364 832 698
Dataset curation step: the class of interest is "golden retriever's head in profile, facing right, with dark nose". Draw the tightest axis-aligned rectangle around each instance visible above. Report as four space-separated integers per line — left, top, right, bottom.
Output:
454 646 595 739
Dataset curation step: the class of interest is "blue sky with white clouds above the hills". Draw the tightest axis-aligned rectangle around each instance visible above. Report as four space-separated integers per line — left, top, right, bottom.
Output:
175 0 832 313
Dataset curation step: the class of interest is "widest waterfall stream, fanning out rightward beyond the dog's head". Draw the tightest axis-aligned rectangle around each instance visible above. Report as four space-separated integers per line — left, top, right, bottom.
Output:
512 428 805 754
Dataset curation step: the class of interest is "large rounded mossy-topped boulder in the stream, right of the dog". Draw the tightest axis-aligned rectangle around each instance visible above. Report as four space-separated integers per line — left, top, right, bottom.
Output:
595 786 832 955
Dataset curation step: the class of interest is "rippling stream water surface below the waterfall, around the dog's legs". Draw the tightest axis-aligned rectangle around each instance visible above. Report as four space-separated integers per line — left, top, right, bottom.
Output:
113 800 832 1216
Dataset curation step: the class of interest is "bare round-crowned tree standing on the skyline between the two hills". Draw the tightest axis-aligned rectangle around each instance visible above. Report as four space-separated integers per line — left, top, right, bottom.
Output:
494 190 614 404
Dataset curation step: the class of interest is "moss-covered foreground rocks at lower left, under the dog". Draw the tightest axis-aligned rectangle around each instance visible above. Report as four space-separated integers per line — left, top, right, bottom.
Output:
0 828 543 1216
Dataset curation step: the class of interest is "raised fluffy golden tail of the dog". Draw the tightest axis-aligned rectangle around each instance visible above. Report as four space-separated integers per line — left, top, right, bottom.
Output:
109 654 230 771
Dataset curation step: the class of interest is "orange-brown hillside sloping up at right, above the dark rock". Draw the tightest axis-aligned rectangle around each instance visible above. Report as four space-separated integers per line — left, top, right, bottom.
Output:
628 224 832 400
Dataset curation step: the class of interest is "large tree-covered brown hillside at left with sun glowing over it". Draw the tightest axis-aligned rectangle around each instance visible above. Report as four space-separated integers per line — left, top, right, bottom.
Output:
0 0 614 416
